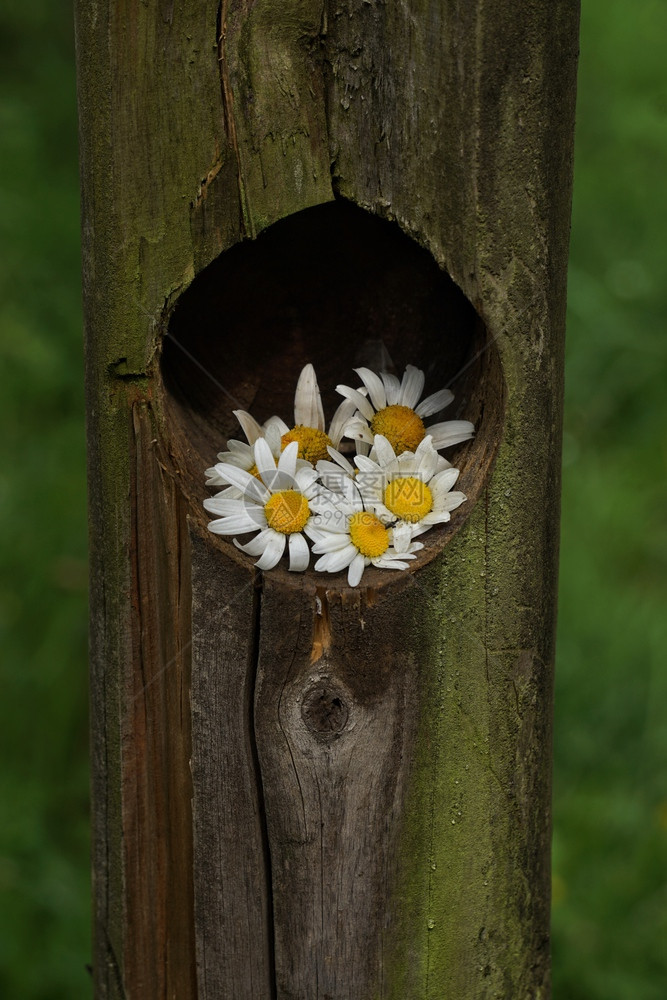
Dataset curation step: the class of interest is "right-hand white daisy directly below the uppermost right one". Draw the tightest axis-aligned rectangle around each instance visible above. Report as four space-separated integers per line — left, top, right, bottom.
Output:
355 434 466 553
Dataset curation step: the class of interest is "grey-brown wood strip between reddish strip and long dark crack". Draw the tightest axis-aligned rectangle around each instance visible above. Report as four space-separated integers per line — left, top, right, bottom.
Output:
192 535 273 1000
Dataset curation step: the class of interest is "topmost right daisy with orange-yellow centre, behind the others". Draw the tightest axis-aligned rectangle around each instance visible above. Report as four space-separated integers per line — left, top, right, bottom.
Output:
336 365 475 455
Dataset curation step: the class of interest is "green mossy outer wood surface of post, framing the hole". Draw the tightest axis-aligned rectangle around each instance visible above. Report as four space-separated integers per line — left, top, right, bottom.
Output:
77 0 577 988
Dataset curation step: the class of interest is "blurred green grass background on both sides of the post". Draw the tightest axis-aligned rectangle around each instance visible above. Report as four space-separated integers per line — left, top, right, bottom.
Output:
0 0 667 1000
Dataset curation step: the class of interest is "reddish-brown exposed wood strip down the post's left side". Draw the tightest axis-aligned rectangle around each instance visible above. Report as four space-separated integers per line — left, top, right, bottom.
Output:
122 402 196 1000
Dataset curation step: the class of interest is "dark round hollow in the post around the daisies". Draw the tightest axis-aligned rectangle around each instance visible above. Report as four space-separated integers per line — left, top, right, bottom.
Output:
161 201 505 590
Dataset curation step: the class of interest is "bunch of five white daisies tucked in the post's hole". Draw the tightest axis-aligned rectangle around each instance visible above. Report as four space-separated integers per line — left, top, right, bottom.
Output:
204 365 474 587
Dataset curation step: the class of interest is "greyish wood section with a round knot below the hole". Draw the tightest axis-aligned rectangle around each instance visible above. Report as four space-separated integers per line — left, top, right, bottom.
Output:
255 577 426 1000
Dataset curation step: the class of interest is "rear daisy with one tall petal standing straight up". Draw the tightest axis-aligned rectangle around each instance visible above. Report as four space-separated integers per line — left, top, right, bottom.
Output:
274 365 356 465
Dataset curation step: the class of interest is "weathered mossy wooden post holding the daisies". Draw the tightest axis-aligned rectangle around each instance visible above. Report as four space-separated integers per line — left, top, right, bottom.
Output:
77 0 578 1000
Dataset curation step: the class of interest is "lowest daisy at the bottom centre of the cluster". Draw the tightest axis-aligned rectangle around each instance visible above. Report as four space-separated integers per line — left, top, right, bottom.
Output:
305 479 423 587
